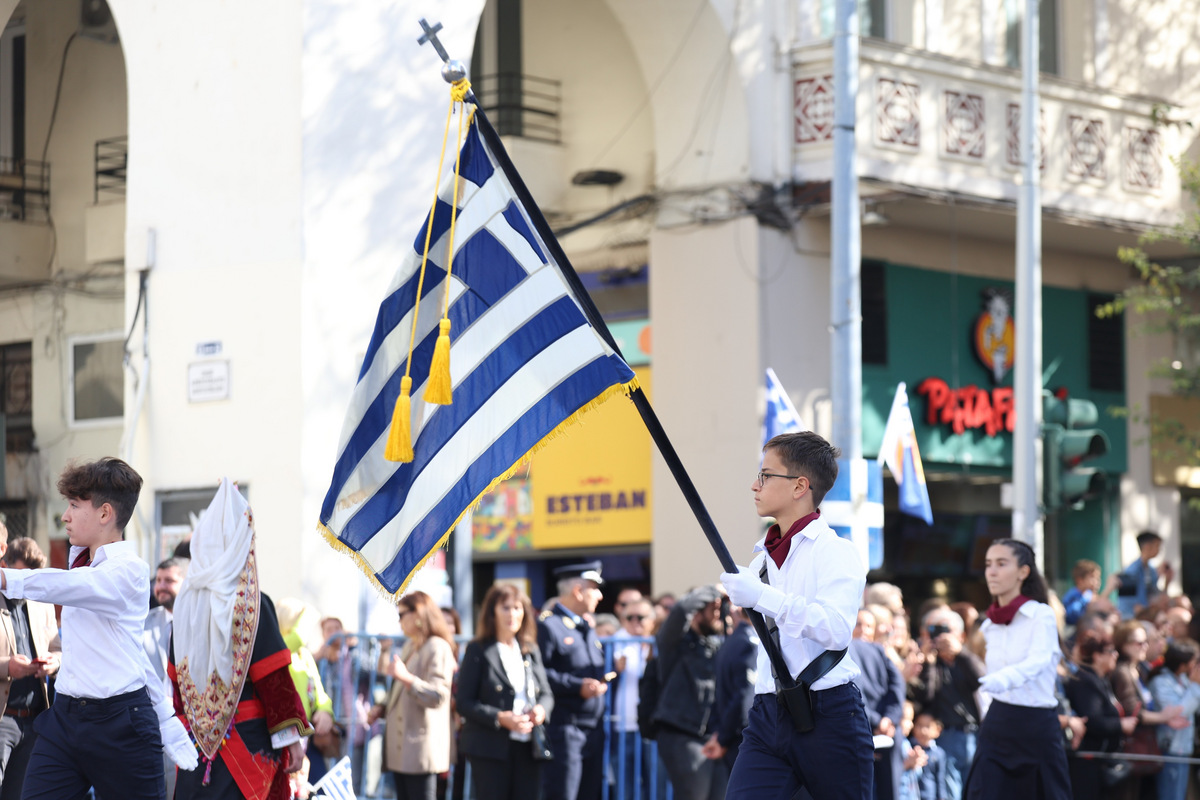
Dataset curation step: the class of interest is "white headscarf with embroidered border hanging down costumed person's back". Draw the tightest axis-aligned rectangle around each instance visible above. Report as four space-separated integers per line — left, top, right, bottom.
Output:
174 477 259 757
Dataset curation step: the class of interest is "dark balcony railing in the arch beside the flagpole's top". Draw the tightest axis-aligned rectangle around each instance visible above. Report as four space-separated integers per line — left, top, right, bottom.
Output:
473 73 563 144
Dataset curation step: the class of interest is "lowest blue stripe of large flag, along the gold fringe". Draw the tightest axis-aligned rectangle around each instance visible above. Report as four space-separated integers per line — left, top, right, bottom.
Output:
376 356 628 591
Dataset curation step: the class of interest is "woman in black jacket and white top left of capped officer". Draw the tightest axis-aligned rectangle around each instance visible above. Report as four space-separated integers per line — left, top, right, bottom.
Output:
455 584 554 800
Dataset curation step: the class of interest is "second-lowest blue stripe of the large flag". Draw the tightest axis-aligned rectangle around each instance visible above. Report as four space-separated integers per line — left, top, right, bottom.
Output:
338 296 587 547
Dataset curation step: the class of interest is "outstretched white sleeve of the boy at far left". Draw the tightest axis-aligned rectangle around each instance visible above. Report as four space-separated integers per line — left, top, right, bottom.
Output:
2 560 132 616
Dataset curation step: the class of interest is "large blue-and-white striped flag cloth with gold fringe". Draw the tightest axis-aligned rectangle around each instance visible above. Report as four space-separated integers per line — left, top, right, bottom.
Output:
320 120 636 595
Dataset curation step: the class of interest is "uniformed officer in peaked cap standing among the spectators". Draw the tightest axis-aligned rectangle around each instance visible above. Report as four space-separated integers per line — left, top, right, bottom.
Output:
538 561 608 800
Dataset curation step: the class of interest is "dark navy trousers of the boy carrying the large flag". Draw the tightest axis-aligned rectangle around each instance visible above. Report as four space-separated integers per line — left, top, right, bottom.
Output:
725 684 875 800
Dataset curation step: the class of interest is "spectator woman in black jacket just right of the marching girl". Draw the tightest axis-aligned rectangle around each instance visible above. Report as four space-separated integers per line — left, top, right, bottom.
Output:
1064 631 1138 800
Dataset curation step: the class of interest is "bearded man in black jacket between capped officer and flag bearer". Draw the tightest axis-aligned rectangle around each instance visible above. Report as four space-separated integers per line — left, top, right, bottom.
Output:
654 587 730 800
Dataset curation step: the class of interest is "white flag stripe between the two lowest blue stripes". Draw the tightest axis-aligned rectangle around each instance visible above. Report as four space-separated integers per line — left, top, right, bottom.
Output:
359 326 602 572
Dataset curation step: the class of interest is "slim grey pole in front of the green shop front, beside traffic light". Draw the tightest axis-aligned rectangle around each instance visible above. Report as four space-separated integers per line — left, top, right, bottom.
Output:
1013 0 1045 566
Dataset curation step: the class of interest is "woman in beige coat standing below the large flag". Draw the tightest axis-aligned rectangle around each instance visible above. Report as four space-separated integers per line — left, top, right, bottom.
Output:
371 591 457 800
